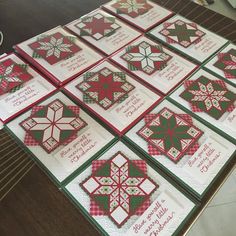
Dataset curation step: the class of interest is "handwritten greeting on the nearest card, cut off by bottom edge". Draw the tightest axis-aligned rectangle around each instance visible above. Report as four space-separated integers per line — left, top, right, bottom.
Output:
126 192 183 236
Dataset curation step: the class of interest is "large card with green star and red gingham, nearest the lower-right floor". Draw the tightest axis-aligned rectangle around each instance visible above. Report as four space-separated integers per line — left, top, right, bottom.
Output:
125 100 236 199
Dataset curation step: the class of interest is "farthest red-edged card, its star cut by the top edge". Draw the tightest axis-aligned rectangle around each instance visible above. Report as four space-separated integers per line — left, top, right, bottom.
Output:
102 0 174 32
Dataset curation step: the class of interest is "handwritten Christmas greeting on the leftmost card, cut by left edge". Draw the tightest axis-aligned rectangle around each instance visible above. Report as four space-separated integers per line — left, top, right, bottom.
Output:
0 80 47 113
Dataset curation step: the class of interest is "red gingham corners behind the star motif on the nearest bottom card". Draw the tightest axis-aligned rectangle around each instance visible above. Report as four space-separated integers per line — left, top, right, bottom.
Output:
90 160 151 216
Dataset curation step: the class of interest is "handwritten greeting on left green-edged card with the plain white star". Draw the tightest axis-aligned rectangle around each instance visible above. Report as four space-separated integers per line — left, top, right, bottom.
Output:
54 128 104 172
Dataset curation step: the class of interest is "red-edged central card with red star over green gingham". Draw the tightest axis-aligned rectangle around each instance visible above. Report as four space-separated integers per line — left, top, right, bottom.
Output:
64 61 161 135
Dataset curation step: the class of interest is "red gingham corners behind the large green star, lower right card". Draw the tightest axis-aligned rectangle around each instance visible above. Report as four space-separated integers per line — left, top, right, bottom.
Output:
144 114 200 156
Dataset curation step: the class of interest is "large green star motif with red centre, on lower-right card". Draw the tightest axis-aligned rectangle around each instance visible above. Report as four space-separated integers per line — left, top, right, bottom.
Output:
137 107 203 162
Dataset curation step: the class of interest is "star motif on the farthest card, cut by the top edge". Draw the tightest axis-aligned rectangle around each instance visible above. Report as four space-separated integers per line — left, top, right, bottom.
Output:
111 0 153 18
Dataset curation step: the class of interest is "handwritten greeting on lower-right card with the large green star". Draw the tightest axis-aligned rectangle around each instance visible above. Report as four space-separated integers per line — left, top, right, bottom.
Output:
184 138 228 183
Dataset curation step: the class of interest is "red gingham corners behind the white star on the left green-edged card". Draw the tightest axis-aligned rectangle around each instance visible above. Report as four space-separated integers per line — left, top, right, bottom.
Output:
24 106 80 146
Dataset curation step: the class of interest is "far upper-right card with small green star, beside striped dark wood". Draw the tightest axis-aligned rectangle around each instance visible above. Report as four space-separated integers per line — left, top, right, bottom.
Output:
148 15 228 63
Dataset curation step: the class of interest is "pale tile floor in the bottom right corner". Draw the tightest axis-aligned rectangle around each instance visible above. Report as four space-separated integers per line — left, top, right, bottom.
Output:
187 168 236 236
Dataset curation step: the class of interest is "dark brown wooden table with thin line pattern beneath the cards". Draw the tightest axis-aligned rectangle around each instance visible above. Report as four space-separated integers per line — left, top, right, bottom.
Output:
0 0 236 236
